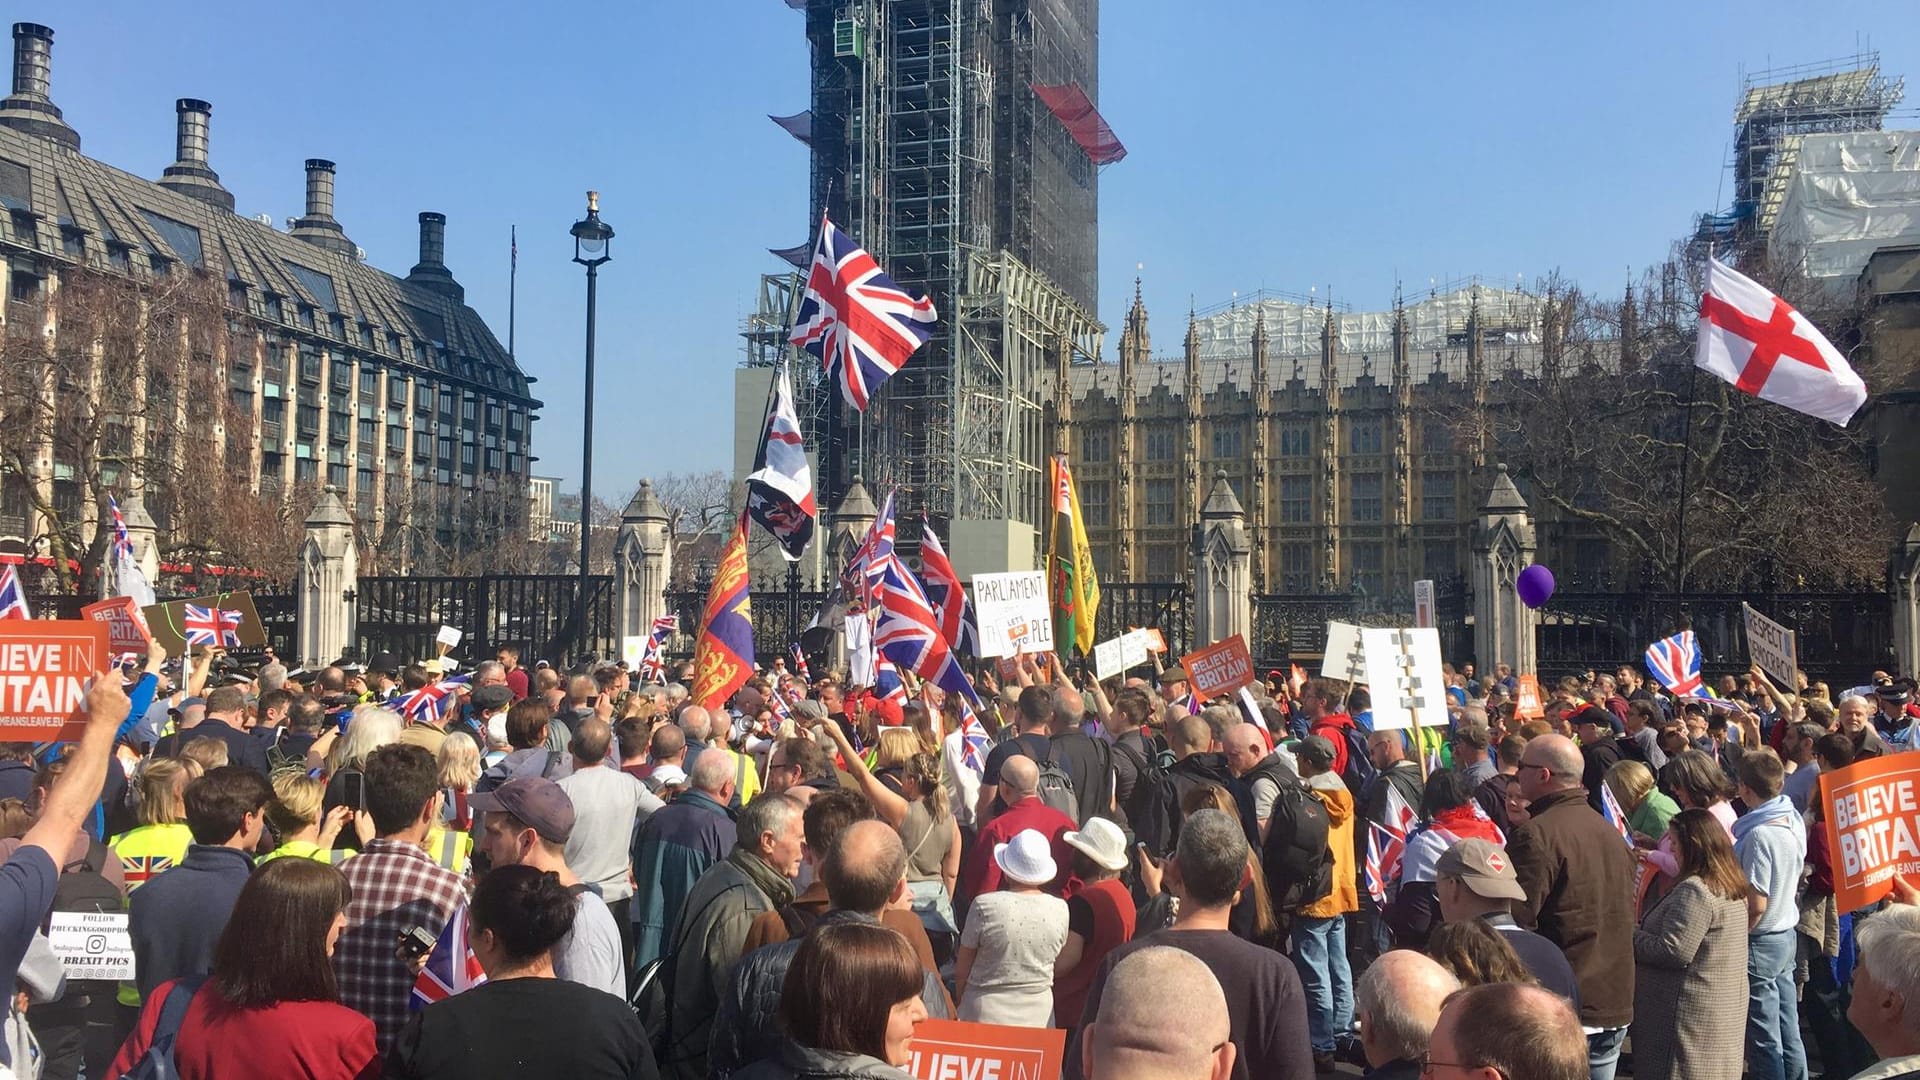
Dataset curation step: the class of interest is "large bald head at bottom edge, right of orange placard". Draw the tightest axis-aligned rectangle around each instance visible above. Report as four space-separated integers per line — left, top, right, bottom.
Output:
1081 945 1235 1080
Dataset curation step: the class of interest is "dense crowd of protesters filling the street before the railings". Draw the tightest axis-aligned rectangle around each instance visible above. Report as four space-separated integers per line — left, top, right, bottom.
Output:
11 630 1920 1080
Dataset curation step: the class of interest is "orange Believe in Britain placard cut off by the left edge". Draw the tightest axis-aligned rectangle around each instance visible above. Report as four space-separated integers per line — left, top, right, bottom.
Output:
0 619 111 742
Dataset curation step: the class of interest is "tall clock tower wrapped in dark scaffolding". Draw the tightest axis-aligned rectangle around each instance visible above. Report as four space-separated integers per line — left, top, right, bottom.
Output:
775 0 1125 553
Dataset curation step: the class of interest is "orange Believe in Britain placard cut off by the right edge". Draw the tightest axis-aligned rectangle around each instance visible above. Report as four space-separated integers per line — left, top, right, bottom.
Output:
1820 753 1920 915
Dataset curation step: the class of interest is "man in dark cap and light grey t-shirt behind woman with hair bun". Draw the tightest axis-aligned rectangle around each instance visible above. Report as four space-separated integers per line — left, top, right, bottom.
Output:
470 776 632 1001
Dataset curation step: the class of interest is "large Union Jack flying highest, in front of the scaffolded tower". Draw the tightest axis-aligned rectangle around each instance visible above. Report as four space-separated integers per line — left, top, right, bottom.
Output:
791 213 935 411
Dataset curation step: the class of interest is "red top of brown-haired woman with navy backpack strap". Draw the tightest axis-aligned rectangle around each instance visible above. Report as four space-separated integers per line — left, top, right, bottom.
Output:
108 982 380 1080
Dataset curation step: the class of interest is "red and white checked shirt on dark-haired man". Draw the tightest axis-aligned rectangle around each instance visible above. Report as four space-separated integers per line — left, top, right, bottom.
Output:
334 840 467 1055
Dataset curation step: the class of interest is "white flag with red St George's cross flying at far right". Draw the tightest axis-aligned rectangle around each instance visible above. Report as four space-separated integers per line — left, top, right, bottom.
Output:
1693 256 1866 427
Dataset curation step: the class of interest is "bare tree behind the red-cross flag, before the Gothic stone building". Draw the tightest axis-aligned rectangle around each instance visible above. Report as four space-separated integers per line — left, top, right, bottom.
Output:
1455 251 1889 588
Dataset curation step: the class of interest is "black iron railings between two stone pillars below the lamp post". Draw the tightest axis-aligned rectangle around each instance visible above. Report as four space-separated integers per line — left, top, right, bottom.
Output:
353 575 618 667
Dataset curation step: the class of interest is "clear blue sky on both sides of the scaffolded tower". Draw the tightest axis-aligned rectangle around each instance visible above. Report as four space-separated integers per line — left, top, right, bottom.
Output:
45 0 1920 496
